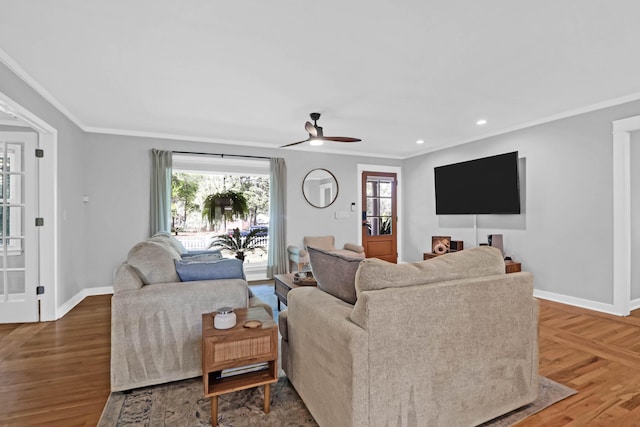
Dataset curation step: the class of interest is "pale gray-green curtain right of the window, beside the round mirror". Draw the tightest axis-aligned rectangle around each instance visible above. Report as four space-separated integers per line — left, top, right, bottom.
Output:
267 158 288 278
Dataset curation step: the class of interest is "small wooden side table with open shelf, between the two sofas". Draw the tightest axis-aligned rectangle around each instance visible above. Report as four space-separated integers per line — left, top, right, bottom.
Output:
202 307 278 426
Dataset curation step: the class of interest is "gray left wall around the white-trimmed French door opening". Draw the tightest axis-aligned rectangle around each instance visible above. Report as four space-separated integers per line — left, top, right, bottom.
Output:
0 63 87 306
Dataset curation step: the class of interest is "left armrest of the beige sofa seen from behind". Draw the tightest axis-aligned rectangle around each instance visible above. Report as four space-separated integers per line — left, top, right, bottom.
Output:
285 287 375 426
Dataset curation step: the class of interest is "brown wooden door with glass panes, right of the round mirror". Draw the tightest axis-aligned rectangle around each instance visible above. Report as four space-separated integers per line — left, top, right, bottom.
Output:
362 171 398 263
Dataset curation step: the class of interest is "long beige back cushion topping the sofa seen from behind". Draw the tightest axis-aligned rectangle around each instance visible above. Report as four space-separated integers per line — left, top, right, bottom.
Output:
355 246 505 294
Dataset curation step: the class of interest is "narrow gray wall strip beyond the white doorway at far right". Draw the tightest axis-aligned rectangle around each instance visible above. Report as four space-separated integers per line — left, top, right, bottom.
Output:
631 131 640 299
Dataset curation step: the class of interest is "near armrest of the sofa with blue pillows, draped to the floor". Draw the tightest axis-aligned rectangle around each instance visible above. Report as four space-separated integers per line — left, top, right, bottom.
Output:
111 279 248 391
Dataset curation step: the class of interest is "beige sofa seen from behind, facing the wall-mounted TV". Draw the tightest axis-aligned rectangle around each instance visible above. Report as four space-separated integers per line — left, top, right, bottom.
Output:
279 247 538 427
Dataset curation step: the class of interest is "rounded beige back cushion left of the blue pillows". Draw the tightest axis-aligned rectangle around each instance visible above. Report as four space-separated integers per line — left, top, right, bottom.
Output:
127 241 180 285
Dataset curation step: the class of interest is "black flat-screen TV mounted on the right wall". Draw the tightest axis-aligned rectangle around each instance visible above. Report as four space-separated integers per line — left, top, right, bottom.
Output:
434 151 520 215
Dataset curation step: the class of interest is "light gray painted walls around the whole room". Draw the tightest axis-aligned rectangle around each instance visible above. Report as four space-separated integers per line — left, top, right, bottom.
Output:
0 54 640 306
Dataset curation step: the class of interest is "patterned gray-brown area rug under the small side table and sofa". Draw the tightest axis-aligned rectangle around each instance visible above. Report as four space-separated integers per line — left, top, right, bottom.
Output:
98 377 576 427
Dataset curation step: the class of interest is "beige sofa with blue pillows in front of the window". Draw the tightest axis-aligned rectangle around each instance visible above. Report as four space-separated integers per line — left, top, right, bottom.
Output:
111 236 272 391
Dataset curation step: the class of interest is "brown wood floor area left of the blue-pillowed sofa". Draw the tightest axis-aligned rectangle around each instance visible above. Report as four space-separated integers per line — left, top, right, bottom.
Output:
0 295 111 427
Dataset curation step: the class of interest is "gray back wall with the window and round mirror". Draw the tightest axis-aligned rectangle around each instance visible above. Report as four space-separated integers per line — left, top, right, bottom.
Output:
83 134 401 287
